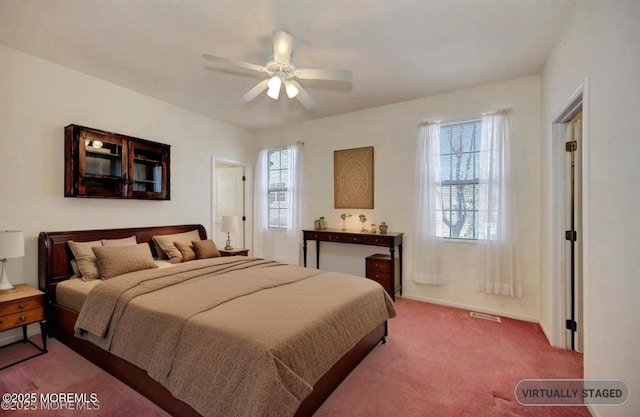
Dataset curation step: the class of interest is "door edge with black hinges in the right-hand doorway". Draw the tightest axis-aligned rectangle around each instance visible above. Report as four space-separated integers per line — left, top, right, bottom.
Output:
564 112 584 352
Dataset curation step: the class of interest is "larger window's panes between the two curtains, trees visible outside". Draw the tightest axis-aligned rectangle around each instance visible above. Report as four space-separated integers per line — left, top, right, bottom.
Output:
436 119 482 239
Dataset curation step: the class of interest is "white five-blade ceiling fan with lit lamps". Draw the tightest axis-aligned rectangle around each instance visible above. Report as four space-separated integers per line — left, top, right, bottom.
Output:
202 30 352 109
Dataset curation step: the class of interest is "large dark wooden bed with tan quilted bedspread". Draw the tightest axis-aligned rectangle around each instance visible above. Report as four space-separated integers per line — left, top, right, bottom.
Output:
38 225 394 417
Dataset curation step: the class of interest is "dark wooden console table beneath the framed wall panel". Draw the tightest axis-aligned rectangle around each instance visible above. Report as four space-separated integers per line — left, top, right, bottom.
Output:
302 229 404 295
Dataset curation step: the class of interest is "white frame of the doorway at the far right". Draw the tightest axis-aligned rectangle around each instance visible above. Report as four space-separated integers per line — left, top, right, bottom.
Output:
548 79 590 348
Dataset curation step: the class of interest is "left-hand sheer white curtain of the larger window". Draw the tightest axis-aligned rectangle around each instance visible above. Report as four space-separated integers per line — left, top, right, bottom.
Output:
412 124 446 285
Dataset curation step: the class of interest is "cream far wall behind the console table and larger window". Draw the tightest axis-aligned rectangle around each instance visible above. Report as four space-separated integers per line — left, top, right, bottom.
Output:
256 76 541 320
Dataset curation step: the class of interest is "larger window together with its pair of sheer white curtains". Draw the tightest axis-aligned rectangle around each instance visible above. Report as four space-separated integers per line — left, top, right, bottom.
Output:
412 110 522 297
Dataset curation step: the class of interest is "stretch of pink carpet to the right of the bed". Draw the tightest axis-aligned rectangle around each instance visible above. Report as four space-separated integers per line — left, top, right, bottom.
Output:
314 299 591 417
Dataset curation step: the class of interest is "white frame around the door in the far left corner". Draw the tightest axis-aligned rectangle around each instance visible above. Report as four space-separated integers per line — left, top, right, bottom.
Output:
209 156 253 250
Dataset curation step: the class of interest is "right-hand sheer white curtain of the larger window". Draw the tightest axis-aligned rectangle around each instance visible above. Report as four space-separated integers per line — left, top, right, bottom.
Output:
476 112 522 297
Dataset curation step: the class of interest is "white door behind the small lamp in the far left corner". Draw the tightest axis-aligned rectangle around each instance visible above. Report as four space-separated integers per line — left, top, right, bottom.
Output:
214 166 245 249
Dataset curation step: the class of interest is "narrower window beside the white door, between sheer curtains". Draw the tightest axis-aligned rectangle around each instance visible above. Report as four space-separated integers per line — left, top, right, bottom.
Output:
267 148 290 229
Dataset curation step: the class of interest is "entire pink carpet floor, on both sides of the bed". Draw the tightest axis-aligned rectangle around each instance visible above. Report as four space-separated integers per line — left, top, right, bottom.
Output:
0 299 590 417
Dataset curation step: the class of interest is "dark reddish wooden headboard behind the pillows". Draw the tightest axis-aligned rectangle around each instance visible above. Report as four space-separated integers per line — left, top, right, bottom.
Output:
38 224 207 302
